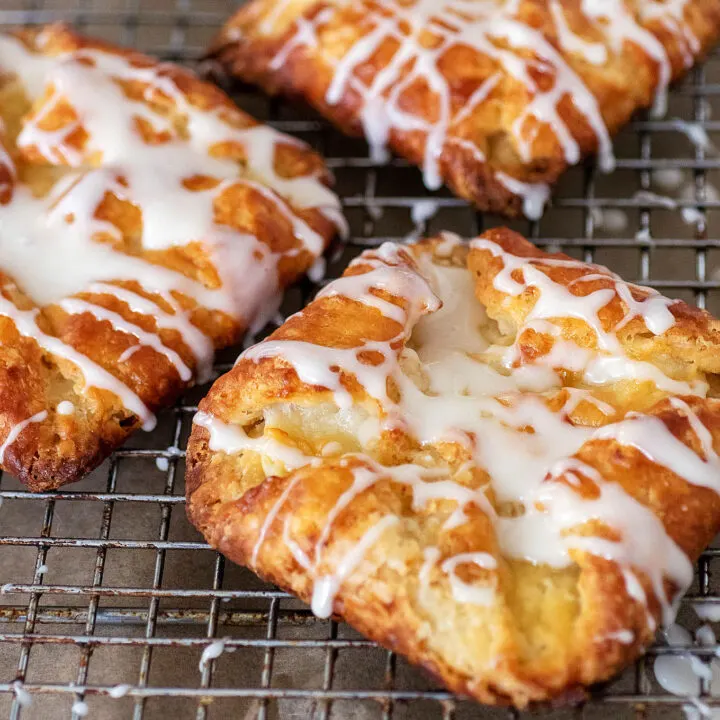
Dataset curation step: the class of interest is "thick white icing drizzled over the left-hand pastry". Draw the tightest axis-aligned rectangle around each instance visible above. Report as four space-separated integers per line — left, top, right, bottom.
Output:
0 30 344 429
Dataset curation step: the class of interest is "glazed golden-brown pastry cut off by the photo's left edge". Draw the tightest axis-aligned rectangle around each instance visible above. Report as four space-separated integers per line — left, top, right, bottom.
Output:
0 26 340 490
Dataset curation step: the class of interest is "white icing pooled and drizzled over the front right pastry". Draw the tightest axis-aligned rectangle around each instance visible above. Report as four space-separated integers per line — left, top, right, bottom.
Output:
201 235 720 632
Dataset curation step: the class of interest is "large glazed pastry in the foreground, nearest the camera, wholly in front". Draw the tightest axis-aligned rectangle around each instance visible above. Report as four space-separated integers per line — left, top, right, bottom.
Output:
187 229 720 707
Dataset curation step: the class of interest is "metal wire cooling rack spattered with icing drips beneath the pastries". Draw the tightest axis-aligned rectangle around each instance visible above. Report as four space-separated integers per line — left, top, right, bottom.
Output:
0 0 720 720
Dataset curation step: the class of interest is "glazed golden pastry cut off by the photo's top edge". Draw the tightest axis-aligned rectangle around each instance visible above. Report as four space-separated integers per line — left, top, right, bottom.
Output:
211 0 720 218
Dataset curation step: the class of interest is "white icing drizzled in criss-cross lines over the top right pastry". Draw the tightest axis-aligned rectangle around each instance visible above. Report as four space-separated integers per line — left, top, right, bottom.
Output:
261 0 699 219
